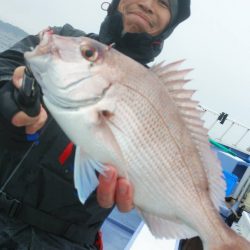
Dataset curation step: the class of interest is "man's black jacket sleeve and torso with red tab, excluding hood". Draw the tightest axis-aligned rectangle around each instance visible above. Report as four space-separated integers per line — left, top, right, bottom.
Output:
0 25 111 248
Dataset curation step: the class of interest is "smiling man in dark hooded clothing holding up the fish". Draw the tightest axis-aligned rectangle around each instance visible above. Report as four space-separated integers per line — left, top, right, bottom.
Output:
0 0 190 250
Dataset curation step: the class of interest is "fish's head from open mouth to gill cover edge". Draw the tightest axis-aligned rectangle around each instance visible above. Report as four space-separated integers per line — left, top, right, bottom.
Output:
24 30 120 109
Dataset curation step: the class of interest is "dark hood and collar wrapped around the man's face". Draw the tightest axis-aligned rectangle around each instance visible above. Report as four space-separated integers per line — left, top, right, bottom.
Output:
99 0 190 64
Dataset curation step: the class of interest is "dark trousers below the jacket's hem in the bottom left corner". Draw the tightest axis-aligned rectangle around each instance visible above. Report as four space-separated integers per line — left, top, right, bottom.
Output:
0 214 97 250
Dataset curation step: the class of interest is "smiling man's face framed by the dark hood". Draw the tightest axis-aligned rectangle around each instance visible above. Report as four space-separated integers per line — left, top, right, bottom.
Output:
118 0 171 36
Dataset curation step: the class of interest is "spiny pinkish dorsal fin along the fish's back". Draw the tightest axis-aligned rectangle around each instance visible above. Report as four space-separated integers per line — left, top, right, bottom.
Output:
151 60 225 209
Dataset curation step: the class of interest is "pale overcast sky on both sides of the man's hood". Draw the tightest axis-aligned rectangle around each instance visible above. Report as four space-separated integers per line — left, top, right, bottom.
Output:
0 0 250 149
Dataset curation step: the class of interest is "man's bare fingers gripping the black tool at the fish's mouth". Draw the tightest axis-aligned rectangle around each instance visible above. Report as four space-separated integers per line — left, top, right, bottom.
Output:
11 66 48 134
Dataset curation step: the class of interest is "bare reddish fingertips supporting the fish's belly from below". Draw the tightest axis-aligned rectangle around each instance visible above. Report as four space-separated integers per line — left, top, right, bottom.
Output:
97 166 134 212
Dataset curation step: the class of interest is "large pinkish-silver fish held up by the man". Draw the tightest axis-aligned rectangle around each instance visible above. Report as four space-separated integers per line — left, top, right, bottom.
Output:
24 31 250 250
